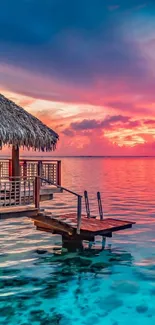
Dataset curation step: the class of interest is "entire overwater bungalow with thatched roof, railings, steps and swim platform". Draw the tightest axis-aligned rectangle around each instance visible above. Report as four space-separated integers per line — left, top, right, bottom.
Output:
0 95 133 247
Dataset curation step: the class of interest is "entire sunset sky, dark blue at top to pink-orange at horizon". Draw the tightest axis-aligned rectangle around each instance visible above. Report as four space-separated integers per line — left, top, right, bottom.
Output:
0 0 155 155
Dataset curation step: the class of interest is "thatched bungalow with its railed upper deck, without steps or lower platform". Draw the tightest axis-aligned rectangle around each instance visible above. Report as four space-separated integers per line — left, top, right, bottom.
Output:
0 95 61 213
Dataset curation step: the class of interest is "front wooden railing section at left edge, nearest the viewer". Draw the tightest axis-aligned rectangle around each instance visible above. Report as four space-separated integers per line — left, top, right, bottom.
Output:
0 177 35 207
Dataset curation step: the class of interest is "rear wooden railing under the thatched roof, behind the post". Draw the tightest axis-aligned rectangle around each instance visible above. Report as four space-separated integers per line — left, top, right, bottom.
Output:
0 159 61 185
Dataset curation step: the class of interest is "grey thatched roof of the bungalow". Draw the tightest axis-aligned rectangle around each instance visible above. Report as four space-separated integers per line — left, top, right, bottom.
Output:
0 94 59 151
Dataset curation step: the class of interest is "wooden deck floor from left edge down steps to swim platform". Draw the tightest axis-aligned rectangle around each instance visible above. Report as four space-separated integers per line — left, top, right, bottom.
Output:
0 205 135 246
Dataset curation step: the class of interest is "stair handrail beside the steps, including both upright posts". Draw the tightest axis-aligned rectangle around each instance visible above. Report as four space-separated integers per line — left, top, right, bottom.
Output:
35 176 82 234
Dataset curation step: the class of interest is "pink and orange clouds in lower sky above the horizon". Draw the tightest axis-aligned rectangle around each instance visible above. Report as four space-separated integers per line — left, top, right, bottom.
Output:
0 58 155 155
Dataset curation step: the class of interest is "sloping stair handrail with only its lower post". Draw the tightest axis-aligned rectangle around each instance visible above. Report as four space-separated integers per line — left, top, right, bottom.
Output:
36 176 82 235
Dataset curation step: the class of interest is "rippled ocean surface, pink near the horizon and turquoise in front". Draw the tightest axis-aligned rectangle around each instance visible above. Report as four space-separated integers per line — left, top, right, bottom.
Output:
0 158 155 325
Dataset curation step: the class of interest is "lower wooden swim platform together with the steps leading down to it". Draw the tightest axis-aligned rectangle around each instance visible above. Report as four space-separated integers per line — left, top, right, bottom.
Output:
33 211 134 239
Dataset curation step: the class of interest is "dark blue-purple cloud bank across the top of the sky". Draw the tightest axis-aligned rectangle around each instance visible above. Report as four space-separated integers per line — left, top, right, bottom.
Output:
0 0 152 85
